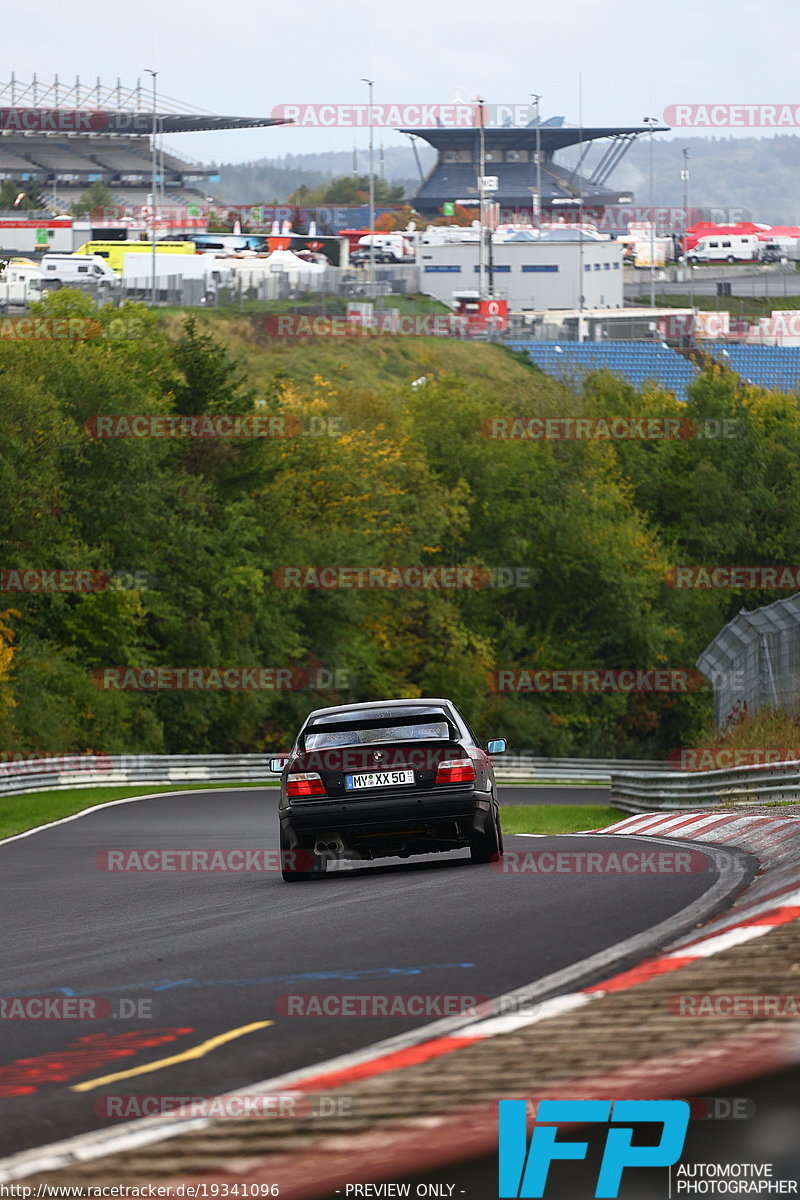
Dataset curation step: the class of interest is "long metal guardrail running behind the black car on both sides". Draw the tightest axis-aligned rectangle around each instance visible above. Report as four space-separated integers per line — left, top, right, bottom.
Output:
0 751 664 798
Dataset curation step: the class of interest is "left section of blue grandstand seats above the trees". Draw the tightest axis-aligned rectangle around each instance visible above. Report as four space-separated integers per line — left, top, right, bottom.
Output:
506 341 700 401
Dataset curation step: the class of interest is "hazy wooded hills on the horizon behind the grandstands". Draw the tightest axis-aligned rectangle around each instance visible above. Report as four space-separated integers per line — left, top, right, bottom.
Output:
213 134 800 224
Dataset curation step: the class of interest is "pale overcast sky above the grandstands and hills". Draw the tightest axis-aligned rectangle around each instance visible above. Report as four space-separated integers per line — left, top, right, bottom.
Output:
0 0 800 162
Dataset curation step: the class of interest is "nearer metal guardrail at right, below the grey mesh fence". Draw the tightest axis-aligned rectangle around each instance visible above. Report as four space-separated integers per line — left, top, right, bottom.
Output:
610 760 800 812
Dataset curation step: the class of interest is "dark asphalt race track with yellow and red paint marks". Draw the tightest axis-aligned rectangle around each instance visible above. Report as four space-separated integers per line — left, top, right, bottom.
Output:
0 787 748 1157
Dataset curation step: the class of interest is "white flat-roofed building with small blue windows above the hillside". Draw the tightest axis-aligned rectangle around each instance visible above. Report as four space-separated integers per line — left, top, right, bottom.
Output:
417 228 624 312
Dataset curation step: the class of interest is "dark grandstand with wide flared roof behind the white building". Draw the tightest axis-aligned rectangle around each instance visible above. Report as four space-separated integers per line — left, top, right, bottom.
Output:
401 116 666 220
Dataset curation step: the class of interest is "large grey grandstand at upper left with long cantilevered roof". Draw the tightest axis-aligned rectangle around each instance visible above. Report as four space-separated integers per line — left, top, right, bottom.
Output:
0 76 285 209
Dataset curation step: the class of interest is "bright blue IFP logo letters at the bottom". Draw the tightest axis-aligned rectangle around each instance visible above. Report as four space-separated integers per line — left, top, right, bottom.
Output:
498 1100 690 1200
